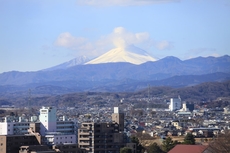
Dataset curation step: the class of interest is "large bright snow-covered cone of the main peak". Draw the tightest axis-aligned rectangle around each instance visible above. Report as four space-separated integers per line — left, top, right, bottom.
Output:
86 45 156 65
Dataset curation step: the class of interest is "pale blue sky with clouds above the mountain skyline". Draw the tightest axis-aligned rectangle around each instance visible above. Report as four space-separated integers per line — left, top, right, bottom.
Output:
0 0 230 73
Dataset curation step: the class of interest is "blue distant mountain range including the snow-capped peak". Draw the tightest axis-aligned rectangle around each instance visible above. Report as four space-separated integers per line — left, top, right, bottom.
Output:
0 46 230 94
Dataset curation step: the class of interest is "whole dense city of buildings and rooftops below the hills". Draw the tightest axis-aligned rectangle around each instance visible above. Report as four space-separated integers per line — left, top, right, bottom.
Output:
0 82 230 153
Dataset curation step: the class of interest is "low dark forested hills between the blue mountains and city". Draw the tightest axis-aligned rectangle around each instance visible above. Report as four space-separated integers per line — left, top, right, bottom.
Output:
0 81 230 107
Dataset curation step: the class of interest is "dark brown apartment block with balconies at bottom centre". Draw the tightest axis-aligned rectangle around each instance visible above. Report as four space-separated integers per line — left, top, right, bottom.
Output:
78 107 126 153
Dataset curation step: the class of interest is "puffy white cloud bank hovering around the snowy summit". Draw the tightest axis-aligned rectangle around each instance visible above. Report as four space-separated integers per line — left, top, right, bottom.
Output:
55 27 173 57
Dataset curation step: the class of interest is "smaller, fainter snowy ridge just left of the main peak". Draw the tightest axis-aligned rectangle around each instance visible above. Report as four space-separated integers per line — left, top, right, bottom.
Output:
44 56 89 71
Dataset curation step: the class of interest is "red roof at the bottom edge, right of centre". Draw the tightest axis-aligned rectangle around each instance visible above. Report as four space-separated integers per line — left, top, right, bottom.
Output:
168 145 208 153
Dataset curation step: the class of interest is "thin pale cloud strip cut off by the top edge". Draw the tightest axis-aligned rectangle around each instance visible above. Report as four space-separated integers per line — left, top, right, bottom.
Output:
77 0 180 6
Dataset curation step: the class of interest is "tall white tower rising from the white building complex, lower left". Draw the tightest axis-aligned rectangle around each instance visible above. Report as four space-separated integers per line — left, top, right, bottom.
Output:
39 107 57 135
